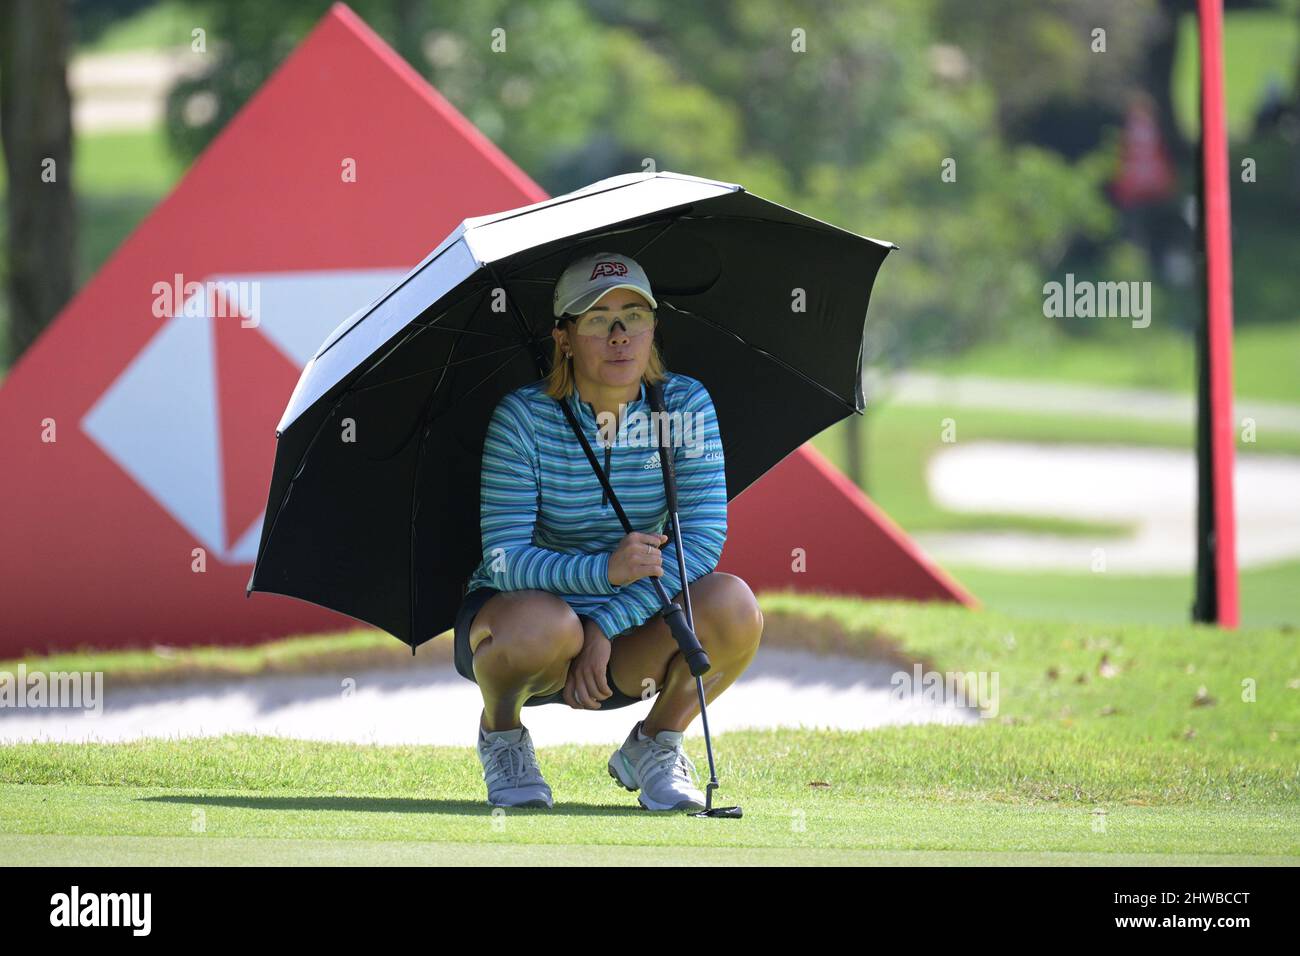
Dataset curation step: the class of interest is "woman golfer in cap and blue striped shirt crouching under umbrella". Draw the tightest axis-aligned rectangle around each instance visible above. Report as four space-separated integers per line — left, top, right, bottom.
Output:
455 252 763 810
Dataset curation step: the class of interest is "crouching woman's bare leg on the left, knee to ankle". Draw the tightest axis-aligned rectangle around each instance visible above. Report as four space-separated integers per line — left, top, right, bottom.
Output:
469 591 582 732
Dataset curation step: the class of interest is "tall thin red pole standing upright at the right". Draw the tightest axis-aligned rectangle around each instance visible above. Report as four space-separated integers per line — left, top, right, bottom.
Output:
1197 0 1239 628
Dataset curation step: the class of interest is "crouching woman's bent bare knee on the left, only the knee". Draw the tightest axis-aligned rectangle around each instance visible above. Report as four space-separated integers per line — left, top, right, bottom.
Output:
475 591 582 674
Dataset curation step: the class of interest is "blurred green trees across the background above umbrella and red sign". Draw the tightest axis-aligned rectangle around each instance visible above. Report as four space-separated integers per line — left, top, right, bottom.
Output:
4 0 1300 367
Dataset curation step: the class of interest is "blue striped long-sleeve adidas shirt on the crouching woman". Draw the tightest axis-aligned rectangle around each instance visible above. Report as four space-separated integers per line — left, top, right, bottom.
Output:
467 372 727 639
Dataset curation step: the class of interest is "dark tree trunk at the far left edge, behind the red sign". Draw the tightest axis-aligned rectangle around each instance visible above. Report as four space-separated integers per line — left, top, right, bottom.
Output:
0 0 77 362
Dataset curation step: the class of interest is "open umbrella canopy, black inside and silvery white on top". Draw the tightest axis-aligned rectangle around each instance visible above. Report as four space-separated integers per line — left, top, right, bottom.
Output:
248 172 896 649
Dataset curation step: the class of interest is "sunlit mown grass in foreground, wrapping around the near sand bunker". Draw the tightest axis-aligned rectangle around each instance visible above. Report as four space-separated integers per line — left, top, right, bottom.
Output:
0 594 1300 865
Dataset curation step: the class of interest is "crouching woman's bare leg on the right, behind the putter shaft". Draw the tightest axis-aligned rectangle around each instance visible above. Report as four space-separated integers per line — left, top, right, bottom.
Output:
610 571 763 736
